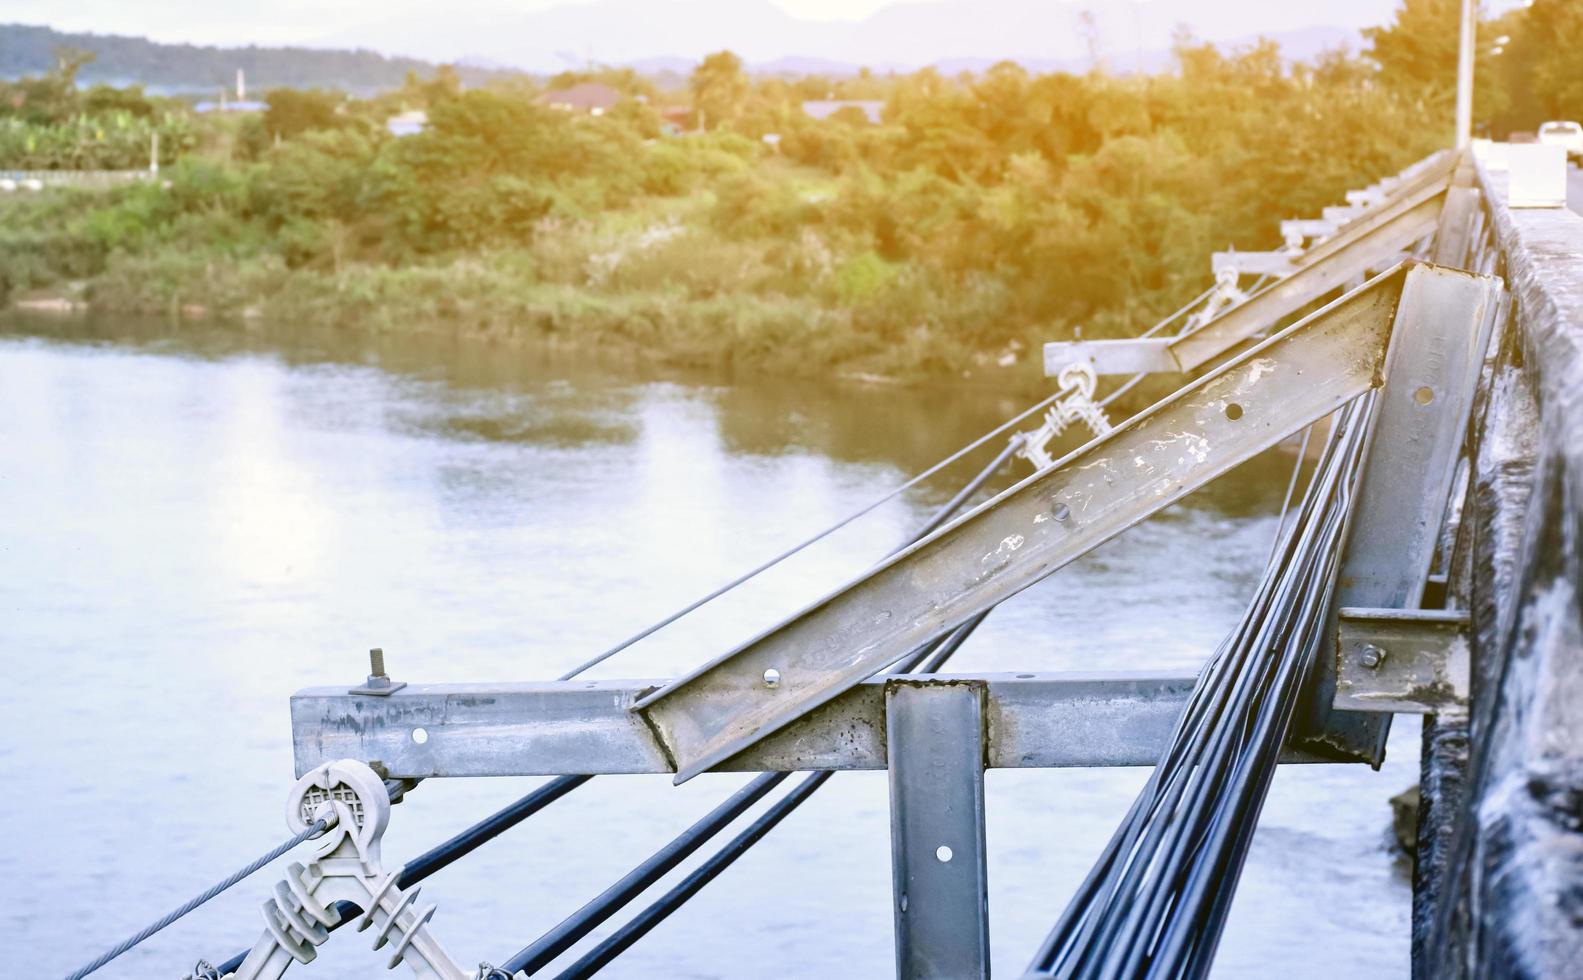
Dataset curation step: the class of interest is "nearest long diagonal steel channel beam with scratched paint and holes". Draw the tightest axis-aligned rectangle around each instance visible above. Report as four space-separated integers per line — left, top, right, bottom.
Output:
636 266 1422 782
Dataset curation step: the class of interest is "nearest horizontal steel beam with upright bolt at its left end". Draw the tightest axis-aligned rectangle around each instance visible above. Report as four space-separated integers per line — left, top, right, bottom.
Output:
291 671 1320 779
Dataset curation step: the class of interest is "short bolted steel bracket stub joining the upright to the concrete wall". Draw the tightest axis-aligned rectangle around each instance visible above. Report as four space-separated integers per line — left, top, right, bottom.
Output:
1334 608 1472 714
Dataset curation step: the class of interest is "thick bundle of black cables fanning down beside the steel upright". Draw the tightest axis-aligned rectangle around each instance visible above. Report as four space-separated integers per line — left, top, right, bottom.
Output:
1029 396 1374 978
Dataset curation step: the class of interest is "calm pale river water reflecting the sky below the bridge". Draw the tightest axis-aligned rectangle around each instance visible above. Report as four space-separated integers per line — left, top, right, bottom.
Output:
0 320 1417 980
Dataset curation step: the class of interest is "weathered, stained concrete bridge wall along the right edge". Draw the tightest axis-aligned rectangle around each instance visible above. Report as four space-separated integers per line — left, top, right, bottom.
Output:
1450 157 1583 978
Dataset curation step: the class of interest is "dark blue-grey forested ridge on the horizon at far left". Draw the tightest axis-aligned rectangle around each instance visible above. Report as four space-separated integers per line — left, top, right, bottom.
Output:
0 24 514 95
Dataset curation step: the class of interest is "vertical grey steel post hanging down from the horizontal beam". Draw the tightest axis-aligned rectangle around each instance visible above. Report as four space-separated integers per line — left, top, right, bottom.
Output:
885 679 989 980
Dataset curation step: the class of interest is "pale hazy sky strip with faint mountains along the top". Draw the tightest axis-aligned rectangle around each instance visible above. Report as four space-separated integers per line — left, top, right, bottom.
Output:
0 0 1520 66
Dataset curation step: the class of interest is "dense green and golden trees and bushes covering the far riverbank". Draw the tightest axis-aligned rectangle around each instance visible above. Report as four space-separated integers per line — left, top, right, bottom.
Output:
0 0 1583 383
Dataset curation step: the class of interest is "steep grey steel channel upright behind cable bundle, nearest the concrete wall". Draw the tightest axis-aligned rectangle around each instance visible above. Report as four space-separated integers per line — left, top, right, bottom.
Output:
1296 266 1505 763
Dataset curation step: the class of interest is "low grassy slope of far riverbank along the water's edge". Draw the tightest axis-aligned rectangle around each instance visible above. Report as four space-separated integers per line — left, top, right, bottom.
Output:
30 252 1048 389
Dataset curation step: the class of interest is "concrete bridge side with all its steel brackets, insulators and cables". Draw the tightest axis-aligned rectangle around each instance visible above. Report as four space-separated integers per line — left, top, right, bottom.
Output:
163 144 1583 980
